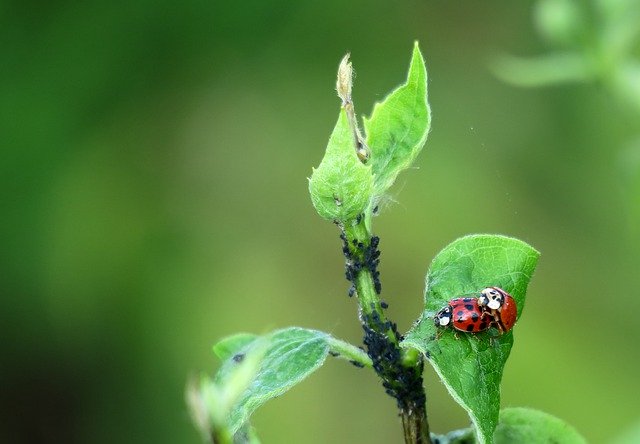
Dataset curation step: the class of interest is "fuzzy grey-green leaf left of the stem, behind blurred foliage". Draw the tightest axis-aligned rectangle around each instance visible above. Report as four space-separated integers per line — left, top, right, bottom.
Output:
215 327 329 433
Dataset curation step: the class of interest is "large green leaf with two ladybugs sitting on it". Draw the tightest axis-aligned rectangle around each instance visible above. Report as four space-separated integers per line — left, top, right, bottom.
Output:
402 235 539 443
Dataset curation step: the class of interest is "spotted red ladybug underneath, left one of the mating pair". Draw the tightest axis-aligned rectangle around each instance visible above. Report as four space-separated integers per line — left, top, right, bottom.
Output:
433 298 492 333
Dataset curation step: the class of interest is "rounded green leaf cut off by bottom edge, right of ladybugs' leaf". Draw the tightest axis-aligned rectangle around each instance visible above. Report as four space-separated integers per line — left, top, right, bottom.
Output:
494 407 587 444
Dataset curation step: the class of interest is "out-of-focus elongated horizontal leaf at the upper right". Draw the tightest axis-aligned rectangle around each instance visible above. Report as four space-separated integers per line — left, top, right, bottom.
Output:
490 52 594 87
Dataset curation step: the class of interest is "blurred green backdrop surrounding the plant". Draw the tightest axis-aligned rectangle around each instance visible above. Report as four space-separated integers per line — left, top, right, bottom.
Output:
0 0 640 444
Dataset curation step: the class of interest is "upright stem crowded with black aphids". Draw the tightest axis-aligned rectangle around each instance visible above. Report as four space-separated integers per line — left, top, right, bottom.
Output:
340 217 431 444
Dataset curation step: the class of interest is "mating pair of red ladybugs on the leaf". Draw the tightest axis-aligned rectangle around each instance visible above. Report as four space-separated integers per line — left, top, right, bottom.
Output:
434 287 518 334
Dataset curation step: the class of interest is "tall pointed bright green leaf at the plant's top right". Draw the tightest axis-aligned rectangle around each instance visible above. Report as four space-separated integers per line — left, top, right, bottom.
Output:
364 42 431 196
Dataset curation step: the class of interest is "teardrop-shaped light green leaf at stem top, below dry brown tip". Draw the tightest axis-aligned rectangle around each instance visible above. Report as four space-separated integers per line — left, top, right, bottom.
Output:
309 108 373 222
